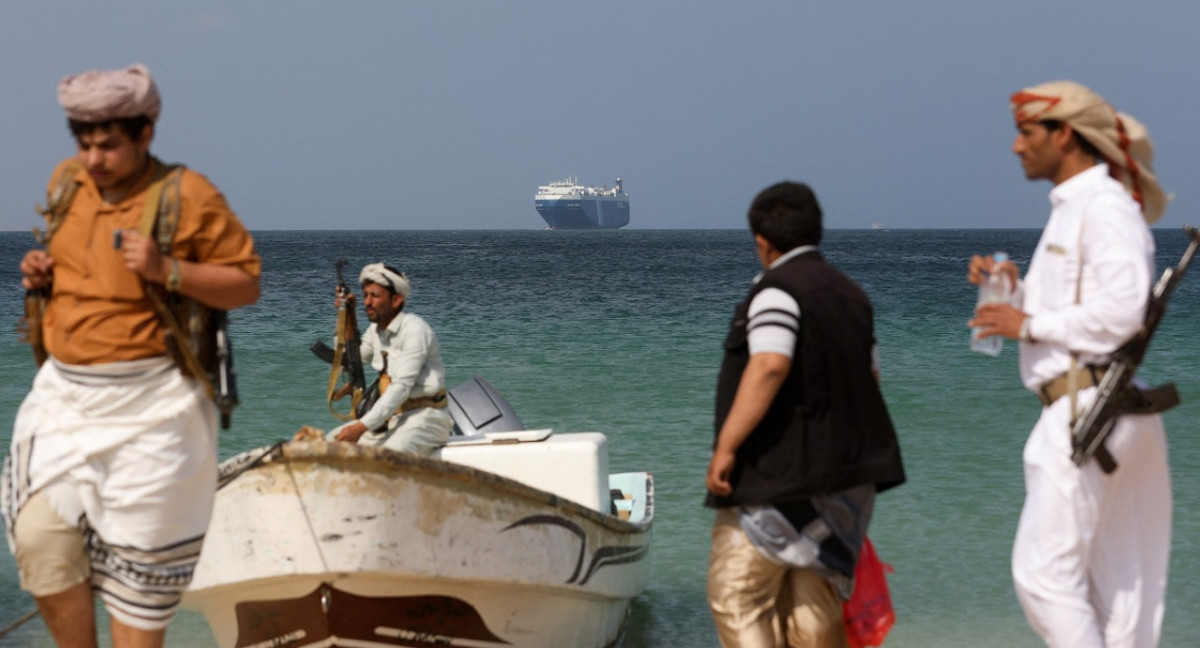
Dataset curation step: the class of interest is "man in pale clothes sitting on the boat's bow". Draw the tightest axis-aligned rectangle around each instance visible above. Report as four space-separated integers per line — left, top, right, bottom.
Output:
328 263 454 456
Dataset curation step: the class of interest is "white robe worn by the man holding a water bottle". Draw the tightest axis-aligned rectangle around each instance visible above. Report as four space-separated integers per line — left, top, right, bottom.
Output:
1013 164 1171 648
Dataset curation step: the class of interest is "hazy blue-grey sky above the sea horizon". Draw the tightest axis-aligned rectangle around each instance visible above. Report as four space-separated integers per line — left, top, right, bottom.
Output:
0 0 1200 229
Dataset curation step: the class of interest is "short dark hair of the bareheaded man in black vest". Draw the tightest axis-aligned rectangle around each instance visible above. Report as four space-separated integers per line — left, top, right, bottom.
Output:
749 181 823 252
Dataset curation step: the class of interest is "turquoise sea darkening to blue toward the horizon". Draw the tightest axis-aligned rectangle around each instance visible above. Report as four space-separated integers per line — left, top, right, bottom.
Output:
0 229 1200 648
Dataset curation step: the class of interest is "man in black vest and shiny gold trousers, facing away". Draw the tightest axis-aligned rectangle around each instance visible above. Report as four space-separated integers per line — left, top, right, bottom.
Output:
704 182 905 648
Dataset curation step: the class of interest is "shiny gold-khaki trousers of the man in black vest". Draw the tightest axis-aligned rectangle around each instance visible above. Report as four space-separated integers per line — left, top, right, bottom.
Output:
708 508 847 648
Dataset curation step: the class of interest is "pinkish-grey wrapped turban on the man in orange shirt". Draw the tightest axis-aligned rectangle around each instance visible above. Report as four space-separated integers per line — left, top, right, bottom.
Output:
59 64 162 124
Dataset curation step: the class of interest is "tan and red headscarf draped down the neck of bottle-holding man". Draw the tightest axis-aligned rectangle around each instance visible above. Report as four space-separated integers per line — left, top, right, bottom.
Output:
1010 82 1171 223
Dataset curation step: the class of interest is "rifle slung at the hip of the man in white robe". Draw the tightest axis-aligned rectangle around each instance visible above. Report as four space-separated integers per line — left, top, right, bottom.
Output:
1070 227 1200 473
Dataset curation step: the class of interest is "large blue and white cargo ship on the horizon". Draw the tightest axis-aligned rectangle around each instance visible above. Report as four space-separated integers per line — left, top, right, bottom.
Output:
533 175 629 229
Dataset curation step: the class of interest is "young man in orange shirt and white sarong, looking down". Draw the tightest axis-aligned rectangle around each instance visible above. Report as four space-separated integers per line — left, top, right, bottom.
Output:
2 65 262 647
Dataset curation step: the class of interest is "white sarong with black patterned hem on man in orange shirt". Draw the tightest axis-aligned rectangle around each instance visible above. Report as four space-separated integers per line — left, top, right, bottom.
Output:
0 358 217 629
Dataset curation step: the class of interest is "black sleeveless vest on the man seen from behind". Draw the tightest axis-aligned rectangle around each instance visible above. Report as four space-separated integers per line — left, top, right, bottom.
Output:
704 252 905 506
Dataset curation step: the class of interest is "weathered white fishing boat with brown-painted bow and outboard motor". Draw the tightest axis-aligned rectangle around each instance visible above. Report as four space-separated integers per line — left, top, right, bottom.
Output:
184 379 654 648
